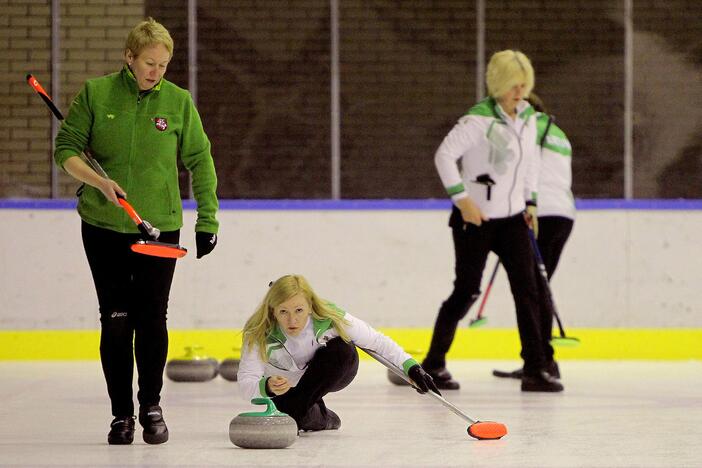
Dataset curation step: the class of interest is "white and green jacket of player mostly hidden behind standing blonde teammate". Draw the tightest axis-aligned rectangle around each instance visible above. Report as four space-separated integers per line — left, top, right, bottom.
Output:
536 112 575 219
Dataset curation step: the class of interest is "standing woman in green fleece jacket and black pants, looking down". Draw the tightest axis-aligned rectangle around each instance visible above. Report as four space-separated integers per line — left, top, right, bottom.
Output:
54 18 219 444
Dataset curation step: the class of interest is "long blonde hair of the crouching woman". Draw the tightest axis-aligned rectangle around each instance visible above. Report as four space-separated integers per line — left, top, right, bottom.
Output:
243 275 351 362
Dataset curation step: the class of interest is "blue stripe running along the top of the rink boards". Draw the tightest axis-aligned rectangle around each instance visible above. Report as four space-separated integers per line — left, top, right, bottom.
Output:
0 198 702 211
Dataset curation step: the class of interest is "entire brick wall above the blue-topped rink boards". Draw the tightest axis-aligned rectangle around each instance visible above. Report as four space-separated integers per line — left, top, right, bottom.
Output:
0 0 702 198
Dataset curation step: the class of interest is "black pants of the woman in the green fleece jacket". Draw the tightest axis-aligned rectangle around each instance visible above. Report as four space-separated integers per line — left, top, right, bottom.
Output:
82 222 180 416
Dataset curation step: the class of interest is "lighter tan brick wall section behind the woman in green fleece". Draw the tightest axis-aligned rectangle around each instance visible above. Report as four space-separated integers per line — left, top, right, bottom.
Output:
0 0 144 197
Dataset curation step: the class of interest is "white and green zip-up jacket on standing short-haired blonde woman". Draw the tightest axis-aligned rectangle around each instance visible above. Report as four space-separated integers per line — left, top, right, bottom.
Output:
434 97 540 218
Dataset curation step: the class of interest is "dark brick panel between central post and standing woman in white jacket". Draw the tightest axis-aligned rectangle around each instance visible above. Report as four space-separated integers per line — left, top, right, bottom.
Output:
339 0 476 198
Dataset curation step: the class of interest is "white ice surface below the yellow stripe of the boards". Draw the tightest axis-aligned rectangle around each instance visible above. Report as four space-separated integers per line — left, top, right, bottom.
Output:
0 360 702 468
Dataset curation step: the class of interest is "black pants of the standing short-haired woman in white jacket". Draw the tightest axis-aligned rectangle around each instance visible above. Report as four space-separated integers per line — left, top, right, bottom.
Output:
424 207 553 375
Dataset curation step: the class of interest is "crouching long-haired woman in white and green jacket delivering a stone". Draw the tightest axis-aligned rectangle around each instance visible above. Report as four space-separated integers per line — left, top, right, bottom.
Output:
237 275 438 431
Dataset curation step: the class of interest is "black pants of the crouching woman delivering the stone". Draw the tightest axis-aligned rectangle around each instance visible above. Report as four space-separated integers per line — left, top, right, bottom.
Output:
273 337 358 426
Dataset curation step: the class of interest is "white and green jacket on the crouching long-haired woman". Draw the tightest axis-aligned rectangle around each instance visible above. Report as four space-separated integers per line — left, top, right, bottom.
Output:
237 306 418 401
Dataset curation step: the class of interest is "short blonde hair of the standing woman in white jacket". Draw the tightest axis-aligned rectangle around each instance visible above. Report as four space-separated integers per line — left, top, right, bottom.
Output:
485 49 534 98
